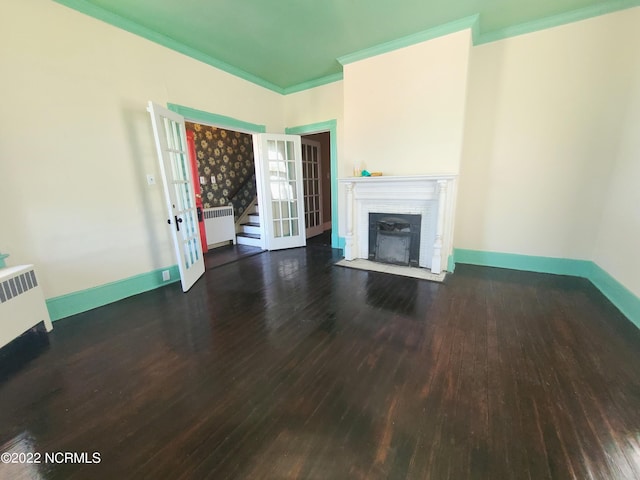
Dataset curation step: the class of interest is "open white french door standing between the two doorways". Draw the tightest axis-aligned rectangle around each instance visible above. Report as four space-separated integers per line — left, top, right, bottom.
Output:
254 133 306 250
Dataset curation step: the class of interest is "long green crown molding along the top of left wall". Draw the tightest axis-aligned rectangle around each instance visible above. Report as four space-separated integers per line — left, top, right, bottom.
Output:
53 0 284 94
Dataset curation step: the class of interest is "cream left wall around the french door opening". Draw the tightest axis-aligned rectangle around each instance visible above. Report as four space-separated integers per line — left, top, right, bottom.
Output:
0 0 284 298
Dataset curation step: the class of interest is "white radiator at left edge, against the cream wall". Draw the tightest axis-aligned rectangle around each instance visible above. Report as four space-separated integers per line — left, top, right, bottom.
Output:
0 265 53 347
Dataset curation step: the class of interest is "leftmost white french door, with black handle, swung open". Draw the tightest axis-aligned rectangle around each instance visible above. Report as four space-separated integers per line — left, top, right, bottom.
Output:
147 102 204 292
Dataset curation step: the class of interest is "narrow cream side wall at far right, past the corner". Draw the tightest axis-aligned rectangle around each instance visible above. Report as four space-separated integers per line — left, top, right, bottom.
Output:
593 8 640 297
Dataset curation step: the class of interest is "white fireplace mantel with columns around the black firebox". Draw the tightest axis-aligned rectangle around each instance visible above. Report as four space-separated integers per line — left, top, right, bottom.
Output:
339 175 457 273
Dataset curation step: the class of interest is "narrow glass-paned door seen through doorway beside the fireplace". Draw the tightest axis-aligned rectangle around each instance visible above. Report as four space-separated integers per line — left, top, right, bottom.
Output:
301 138 323 238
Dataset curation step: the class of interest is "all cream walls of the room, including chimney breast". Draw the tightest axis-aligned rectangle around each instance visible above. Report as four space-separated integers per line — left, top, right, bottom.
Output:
0 0 640 304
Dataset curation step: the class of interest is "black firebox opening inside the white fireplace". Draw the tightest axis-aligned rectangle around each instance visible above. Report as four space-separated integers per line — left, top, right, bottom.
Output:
369 213 422 267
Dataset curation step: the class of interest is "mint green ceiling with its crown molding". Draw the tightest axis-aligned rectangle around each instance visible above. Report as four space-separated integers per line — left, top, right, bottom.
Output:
55 0 640 93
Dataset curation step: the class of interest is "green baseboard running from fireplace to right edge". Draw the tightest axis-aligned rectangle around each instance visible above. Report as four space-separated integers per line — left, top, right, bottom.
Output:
450 248 640 328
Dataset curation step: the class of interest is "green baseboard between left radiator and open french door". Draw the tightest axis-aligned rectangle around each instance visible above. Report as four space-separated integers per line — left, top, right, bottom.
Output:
46 265 180 321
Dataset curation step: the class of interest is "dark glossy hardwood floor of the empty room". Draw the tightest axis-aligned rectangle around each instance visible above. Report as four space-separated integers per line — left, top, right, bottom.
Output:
0 247 640 480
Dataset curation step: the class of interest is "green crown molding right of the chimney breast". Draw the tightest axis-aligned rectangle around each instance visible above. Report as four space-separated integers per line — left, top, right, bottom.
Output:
474 0 640 45
